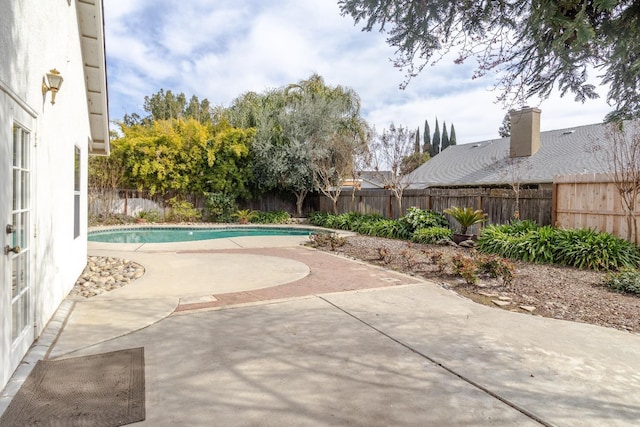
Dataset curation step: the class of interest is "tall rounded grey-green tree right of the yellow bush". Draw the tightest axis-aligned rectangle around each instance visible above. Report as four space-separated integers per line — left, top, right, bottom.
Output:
254 74 367 215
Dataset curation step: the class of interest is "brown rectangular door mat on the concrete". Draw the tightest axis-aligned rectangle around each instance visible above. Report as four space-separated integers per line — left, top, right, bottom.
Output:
0 347 145 427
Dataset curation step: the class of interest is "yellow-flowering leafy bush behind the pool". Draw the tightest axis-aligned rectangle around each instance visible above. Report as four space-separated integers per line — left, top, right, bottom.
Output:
112 119 254 196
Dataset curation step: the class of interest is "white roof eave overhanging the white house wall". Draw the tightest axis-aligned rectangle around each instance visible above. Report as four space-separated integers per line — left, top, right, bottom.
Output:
76 0 110 155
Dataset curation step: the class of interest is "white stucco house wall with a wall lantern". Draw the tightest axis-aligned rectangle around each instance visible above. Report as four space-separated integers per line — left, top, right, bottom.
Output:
0 0 90 388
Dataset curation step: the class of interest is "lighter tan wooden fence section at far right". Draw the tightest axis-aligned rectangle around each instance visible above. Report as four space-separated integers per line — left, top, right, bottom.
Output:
552 174 640 243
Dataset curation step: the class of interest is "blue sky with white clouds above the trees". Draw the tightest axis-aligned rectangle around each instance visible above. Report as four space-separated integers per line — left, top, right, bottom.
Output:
104 0 611 144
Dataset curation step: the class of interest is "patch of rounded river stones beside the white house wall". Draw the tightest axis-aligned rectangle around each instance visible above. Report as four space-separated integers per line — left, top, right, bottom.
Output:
69 256 145 299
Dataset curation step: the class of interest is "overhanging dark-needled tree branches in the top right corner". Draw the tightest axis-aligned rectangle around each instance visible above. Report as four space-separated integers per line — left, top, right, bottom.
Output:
338 0 640 120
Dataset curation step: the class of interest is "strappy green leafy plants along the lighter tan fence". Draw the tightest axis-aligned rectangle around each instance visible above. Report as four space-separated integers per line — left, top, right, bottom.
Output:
477 221 640 270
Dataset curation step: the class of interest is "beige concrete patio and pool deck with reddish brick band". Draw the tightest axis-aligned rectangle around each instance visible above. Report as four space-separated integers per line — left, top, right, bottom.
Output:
0 237 640 426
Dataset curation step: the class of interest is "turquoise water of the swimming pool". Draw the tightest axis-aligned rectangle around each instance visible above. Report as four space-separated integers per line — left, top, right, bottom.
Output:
88 227 317 243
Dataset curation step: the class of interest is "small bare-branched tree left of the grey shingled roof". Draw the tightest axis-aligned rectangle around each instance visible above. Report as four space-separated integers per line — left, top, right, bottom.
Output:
369 123 415 214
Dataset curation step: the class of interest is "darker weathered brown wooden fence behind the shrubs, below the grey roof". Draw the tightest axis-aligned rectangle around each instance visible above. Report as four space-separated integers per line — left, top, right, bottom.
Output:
319 188 552 231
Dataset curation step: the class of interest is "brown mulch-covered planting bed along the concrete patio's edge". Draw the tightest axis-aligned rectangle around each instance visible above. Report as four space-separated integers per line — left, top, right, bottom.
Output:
318 236 640 333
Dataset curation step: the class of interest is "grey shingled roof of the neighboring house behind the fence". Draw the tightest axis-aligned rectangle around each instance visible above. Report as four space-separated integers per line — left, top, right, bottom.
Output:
408 123 607 188
